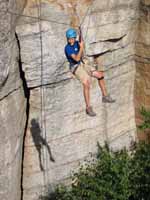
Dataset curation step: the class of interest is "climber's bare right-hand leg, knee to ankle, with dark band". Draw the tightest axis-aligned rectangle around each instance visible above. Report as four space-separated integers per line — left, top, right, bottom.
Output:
92 71 107 96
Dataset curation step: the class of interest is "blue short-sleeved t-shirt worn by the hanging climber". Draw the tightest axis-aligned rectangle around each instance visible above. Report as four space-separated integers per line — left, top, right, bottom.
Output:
65 41 80 68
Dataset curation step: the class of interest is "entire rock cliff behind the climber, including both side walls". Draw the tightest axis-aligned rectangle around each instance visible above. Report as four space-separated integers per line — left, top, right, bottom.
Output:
0 0 150 200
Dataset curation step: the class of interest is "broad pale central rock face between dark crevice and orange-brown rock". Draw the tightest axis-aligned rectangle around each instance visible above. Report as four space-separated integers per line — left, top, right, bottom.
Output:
14 0 139 200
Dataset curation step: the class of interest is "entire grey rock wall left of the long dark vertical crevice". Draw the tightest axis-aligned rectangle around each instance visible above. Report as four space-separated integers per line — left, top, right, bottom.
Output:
0 0 26 200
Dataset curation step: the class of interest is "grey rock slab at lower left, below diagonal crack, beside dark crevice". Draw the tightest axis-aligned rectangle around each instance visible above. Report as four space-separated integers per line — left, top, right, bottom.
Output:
0 89 26 200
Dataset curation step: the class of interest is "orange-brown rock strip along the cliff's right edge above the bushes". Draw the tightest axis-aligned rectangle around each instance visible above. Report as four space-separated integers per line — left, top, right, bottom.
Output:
135 0 150 139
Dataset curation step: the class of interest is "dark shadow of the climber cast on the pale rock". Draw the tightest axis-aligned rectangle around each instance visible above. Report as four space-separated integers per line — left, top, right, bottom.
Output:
30 119 55 171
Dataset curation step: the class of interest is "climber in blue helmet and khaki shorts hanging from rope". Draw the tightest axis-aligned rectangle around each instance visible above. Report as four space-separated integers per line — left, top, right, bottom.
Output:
65 28 115 117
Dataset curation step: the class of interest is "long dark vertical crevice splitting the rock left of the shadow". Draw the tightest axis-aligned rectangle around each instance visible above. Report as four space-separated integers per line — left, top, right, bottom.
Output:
15 33 30 200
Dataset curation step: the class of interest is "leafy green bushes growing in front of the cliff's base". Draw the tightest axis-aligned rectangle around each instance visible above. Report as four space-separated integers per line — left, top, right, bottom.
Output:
41 143 150 200
